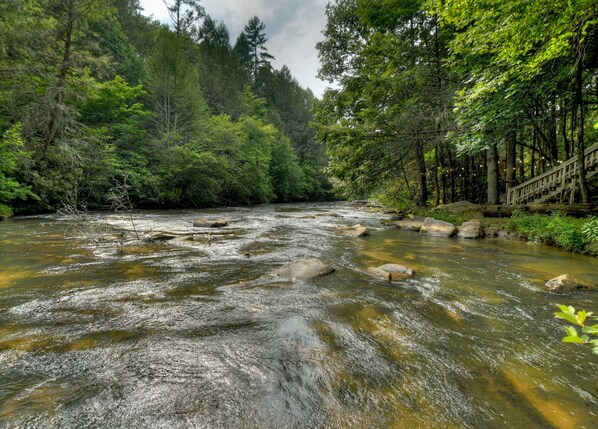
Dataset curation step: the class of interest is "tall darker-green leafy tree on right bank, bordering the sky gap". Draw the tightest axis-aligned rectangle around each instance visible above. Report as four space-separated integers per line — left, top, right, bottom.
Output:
316 0 452 206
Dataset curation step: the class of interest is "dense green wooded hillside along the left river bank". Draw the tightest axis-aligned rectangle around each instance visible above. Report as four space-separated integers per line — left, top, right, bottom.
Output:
0 0 330 213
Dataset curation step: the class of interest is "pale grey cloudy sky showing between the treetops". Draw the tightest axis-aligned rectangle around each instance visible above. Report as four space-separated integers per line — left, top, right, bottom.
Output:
140 0 328 97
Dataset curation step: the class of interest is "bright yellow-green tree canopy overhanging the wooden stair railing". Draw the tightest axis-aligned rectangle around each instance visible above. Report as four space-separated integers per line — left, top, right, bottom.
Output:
437 0 598 202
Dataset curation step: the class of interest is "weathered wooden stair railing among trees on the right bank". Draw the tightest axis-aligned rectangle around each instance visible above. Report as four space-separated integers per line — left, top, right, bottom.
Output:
507 144 598 204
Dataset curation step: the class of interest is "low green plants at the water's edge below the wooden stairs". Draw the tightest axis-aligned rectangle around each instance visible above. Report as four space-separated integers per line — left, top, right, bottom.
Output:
506 212 598 255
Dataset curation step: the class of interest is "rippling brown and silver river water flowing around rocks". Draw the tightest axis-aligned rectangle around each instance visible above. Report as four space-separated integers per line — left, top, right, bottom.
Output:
0 204 598 429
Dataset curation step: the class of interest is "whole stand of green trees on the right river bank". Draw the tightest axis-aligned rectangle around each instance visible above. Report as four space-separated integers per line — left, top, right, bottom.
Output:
315 0 598 206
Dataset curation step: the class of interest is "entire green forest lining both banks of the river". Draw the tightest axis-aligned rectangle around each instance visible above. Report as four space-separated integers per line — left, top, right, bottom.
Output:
0 0 598 217
